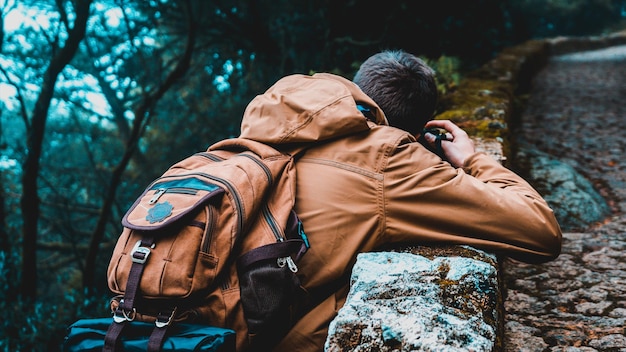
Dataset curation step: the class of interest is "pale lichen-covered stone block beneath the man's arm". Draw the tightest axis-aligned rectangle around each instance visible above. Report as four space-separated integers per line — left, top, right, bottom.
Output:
325 248 499 352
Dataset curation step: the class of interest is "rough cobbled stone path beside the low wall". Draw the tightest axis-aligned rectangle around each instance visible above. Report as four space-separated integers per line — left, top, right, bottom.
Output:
503 46 626 352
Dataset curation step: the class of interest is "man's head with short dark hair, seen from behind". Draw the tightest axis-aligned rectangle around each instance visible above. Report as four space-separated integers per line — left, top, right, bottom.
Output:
353 50 437 134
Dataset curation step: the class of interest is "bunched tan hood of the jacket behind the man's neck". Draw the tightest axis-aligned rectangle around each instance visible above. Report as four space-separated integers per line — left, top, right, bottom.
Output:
240 73 388 145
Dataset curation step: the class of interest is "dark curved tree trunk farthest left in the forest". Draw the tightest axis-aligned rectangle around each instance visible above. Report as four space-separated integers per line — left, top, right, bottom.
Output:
20 0 92 299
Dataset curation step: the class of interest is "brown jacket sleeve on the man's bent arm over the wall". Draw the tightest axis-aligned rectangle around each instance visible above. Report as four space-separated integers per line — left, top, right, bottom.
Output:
384 143 562 263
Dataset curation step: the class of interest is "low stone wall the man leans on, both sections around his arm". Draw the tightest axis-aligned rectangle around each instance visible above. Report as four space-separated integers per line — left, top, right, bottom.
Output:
325 31 626 352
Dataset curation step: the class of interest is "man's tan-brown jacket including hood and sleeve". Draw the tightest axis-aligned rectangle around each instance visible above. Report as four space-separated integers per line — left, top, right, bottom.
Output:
236 74 561 351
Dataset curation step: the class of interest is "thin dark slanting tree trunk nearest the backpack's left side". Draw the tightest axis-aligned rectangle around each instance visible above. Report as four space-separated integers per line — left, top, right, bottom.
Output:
83 1 196 293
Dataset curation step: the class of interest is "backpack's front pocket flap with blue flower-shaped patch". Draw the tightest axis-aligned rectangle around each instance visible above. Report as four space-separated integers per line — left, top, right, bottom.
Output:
122 176 224 231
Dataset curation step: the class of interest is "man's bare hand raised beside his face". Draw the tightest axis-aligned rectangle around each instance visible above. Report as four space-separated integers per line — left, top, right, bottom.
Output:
424 120 476 167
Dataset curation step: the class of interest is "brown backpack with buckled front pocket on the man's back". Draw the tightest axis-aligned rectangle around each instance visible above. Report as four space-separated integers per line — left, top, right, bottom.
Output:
105 138 308 351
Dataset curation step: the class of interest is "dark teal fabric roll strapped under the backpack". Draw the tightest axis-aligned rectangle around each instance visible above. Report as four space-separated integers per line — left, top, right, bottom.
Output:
63 318 235 352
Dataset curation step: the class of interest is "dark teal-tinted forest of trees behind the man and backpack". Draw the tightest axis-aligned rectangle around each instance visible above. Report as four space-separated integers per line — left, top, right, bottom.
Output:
0 0 626 351
